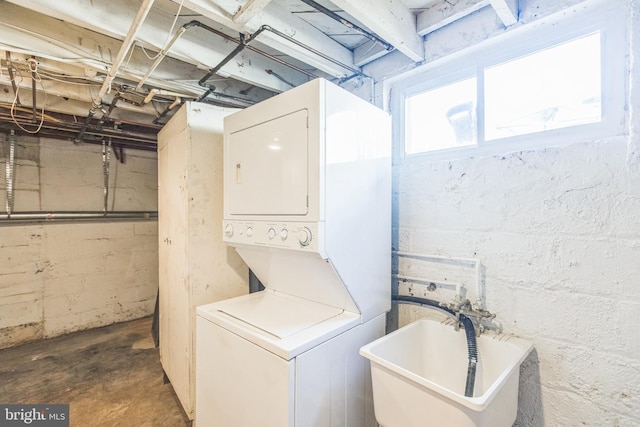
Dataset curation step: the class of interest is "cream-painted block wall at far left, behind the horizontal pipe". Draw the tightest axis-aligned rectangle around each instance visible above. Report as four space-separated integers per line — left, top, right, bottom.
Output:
0 136 158 348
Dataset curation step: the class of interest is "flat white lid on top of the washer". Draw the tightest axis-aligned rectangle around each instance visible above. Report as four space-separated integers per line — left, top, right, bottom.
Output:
217 291 343 339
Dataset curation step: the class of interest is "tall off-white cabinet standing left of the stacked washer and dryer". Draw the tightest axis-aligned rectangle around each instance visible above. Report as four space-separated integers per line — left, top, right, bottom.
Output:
158 102 249 419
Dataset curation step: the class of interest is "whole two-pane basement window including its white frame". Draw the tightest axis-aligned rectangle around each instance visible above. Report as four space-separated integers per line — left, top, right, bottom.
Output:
392 1 626 156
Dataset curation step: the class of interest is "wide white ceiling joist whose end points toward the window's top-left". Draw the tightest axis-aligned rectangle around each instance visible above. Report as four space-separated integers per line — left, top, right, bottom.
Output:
332 0 424 62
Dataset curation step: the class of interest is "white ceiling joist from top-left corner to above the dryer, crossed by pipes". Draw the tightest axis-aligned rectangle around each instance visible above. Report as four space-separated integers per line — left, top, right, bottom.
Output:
0 0 308 93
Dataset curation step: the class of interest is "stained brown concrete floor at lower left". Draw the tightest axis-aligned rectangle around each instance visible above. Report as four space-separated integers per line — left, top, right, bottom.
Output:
0 318 191 427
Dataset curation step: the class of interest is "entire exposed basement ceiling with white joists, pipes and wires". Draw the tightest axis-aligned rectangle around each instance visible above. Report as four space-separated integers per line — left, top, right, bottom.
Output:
0 0 518 150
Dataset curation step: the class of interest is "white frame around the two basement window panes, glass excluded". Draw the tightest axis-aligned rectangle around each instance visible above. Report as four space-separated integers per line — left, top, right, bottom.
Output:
387 1 629 159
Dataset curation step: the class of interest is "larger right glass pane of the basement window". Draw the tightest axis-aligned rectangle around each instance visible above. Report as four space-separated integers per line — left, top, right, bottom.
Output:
484 33 602 140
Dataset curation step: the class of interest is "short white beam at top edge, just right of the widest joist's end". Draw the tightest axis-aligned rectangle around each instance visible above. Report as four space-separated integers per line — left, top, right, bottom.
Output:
417 0 490 36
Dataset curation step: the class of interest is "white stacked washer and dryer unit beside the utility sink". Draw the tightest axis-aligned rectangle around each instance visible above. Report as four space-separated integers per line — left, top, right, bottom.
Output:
196 79 391 427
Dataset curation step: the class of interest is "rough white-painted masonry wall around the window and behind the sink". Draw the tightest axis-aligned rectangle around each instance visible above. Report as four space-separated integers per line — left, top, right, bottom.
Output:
370 0 640 427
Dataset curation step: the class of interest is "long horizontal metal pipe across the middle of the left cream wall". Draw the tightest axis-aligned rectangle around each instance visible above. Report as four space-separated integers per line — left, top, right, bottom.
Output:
0 211 158 223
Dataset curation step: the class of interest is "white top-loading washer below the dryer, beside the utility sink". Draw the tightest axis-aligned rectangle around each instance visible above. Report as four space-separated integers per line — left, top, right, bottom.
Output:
196 290 385 427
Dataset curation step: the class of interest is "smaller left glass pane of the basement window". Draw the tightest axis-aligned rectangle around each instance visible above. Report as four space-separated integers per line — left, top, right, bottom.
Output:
405 77 477 154
